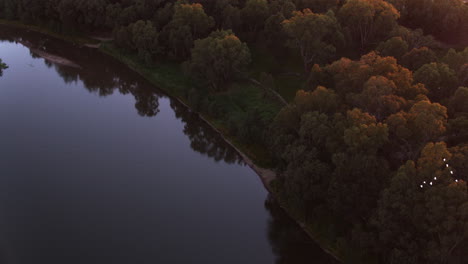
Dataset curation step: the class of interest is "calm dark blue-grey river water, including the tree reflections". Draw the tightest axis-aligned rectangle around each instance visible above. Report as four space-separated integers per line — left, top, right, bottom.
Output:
0 27 333 264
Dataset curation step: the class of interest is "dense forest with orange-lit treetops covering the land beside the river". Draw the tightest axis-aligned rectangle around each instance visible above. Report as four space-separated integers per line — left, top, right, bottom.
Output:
0 0 468 264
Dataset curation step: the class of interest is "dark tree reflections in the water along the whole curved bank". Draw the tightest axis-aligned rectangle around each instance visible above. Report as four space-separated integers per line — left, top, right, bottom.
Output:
0 27 336 264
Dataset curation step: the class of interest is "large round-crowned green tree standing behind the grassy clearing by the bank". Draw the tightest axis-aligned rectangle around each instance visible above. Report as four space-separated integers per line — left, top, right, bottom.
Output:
188 31 251 90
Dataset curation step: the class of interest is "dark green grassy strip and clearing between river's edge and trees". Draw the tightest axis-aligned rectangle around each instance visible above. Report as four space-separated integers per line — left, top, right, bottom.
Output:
100 42 281 167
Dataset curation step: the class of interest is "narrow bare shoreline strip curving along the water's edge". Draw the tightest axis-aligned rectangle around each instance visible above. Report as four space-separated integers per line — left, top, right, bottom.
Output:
0 20 344 263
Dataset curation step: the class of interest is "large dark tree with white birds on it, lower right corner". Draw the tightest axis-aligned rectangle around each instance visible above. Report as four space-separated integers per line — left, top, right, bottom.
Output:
374 143 468 263
